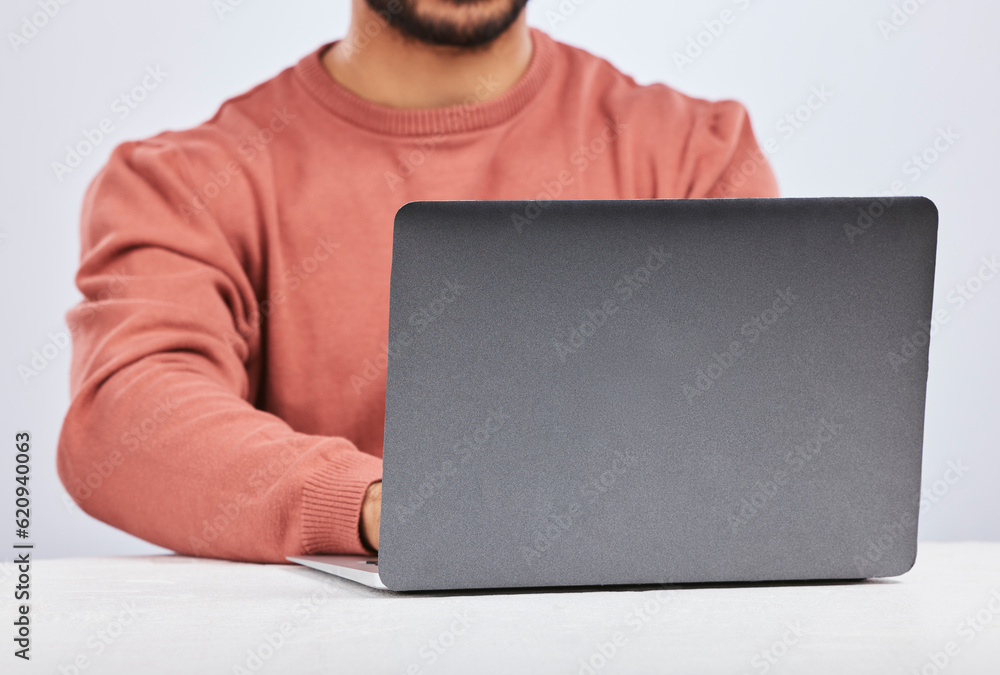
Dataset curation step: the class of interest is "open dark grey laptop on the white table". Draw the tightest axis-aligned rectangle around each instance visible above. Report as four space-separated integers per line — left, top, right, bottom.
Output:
289 197 937 591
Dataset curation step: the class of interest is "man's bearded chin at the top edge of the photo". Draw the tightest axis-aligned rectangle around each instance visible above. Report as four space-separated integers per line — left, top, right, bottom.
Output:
365 0 528 49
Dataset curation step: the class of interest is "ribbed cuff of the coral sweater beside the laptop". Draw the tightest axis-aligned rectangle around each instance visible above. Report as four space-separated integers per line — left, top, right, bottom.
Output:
302 450 382 555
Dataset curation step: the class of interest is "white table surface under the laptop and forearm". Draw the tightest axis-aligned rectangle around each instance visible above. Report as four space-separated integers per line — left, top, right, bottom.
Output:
7 543 1000 675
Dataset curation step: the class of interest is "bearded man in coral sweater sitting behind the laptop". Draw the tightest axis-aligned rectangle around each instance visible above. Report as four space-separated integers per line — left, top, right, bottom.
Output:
58 0 777 561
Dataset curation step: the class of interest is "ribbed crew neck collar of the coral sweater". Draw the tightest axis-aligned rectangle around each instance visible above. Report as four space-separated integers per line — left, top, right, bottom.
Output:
295 28 556 136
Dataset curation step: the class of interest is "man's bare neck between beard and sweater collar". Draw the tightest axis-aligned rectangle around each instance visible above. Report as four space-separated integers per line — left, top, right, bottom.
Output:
323 0 532 108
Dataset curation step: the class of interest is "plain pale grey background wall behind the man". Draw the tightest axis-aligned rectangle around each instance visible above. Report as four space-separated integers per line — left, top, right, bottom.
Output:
0 0 1000 557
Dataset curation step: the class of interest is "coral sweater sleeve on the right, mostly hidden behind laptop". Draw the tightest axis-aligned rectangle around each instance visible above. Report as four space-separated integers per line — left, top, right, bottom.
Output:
687 101 779 198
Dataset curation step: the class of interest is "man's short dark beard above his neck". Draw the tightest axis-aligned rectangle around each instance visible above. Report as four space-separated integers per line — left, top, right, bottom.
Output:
365 0 528 47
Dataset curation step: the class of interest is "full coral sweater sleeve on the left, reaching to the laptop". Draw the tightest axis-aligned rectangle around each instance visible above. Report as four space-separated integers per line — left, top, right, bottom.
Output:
58 137 382 562
